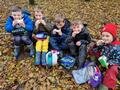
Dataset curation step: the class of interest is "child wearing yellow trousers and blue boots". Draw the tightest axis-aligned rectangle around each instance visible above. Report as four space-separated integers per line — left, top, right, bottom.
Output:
32 7 50 66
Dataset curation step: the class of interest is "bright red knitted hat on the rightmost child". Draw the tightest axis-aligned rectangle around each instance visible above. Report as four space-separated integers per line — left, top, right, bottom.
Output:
102 23 117 38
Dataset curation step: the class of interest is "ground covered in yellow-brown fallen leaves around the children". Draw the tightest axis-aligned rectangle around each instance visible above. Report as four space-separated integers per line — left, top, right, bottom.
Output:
0 0 120 90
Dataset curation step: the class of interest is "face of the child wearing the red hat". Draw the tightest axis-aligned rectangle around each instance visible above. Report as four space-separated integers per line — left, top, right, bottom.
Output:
102 32 113 44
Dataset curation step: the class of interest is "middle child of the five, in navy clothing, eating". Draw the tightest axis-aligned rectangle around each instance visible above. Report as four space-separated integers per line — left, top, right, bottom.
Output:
50 14 70 54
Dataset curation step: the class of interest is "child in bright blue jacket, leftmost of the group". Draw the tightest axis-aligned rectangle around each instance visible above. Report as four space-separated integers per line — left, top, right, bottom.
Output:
5 6 34 60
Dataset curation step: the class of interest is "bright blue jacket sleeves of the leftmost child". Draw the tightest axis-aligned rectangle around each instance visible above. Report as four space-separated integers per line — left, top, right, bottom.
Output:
5 15 33 33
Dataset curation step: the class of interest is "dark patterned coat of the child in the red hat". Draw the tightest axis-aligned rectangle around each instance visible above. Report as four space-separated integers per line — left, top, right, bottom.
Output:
89 42 120 65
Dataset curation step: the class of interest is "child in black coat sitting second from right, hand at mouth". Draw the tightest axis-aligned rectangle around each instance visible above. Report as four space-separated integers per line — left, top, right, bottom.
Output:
66 20 91 69
